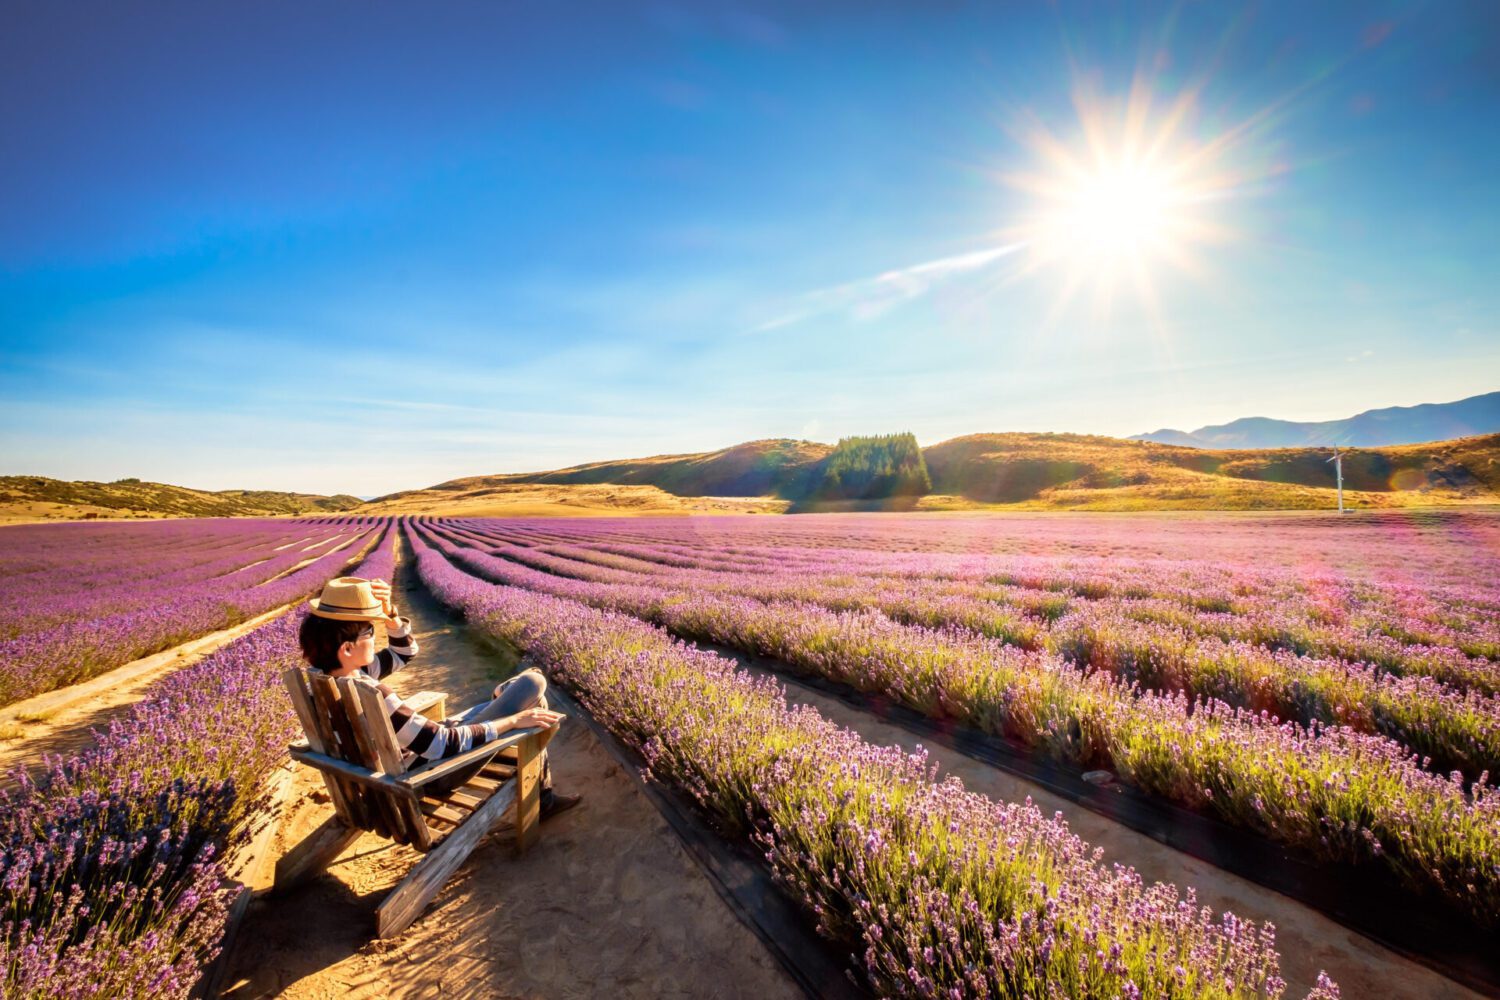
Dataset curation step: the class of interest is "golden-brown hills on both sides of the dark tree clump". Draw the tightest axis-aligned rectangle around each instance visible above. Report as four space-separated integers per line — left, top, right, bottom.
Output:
372 433 1500 517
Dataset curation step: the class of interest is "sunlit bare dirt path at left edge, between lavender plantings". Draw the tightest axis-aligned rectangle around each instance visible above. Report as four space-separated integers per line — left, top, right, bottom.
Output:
0 604 291 787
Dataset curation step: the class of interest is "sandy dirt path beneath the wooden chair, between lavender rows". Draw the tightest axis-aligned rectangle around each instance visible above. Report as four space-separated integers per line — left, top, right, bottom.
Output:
222 544 801 999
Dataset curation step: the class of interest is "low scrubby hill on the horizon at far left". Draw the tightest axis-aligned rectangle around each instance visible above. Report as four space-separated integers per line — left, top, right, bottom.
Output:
0 475 362 522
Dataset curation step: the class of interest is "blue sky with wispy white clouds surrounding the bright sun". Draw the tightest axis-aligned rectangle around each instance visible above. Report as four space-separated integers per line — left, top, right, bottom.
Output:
0 0 1500 495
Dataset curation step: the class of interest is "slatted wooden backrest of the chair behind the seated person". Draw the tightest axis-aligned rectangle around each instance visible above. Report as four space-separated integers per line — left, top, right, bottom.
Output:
282 667 431 847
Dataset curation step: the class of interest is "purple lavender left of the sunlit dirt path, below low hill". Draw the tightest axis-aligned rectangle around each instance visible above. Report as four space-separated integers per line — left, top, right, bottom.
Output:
0 522 375 705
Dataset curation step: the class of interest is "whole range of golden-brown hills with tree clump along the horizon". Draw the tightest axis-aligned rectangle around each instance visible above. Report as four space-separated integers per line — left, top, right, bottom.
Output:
14 433 1500 522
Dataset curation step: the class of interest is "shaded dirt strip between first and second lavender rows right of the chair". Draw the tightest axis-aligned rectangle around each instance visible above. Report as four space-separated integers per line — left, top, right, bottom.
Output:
732 649 1481 1000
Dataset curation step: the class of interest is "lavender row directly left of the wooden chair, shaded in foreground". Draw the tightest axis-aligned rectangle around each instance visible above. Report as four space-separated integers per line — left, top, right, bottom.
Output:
0 529 398 1000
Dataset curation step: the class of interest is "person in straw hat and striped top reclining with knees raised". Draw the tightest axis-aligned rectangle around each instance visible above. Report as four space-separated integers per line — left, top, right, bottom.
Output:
297 576 582 819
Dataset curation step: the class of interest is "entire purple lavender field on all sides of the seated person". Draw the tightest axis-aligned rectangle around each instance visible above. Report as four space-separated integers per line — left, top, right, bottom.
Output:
0 514 1500 997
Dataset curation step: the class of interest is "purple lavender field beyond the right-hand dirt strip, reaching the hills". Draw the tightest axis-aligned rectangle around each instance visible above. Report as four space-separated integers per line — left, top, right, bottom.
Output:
419 516 1500 924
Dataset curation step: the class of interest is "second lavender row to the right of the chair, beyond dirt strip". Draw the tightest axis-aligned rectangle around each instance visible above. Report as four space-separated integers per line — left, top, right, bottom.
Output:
419 525 1500 922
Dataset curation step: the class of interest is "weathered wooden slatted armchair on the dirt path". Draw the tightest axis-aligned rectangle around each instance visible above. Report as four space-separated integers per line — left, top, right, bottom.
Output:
273 667 557 937
